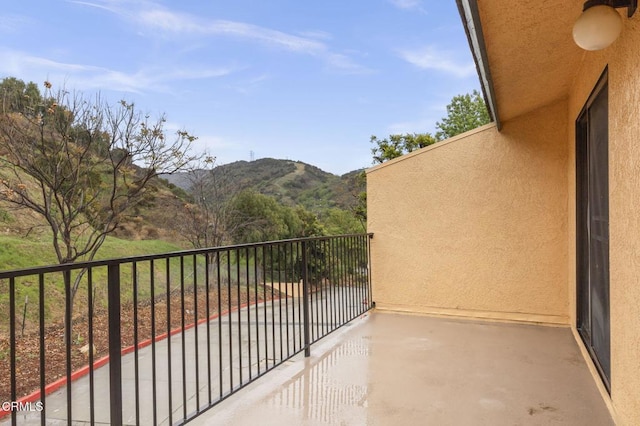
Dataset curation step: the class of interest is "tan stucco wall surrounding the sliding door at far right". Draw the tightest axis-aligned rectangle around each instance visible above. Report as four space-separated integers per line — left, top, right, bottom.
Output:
568 13 640 425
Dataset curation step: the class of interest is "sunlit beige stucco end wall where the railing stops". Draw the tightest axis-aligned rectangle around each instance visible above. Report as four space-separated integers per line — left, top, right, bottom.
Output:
367 101 569 323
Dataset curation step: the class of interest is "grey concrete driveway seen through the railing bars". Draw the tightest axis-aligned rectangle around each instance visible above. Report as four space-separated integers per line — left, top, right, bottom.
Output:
0 287 363 426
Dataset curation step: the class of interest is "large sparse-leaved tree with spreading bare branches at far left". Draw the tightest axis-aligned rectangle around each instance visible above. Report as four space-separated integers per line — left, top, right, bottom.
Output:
0 82 196 302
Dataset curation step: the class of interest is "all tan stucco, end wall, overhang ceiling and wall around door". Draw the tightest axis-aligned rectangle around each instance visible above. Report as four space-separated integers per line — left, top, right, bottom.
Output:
367 0 640 426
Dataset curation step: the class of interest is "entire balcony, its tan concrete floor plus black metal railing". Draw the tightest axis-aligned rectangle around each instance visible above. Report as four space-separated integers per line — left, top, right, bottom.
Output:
0 235 613 425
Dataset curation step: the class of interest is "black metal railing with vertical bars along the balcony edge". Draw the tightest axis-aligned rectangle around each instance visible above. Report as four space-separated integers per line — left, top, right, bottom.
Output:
0 234 373 425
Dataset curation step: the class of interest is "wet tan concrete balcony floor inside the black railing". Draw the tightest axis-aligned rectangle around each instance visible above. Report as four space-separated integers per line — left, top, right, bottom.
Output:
195 312 614 426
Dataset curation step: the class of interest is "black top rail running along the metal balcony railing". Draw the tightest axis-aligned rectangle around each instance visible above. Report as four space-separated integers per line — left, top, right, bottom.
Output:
0 232 373 279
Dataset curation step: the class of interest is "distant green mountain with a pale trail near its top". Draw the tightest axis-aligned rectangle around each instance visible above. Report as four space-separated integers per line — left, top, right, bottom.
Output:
161 158 365 214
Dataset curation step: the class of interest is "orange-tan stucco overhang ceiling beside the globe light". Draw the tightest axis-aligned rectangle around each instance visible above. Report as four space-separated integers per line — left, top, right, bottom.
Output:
477 0 584 121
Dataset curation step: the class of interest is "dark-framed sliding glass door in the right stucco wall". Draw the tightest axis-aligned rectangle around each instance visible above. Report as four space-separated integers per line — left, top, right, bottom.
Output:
576 71 611 388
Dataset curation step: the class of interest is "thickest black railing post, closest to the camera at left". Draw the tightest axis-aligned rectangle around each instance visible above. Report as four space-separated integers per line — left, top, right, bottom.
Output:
107 263 122 426
